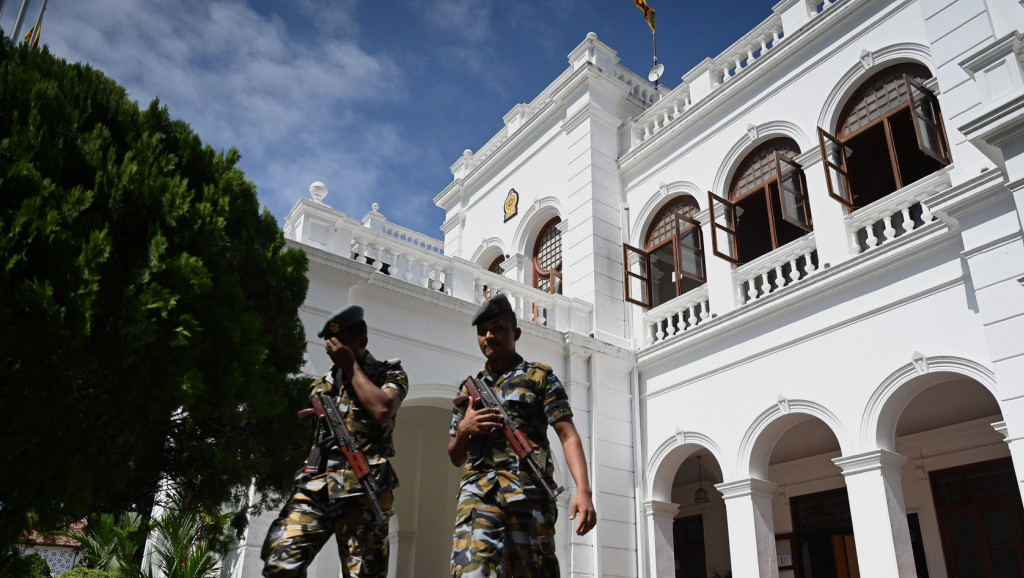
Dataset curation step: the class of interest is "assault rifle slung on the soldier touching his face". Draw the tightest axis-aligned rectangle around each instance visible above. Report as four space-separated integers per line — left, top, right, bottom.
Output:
299 393 394 524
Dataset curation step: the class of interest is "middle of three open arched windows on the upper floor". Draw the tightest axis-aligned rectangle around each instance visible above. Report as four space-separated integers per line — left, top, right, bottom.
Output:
708 138 813 264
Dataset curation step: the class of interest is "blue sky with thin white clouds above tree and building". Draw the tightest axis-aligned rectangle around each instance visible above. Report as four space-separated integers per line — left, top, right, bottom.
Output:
0 0 775 238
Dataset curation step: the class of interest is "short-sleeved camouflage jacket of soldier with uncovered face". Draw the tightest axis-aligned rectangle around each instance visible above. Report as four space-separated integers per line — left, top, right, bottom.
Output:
449 356 572 501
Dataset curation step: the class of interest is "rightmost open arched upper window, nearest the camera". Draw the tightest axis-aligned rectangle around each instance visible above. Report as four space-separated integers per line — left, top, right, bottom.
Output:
818 64 950 210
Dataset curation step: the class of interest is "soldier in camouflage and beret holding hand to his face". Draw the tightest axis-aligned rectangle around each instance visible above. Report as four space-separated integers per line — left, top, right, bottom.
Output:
261 305 409 578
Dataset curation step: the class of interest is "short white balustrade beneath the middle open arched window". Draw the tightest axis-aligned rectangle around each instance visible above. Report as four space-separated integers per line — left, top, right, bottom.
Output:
733 233 821 305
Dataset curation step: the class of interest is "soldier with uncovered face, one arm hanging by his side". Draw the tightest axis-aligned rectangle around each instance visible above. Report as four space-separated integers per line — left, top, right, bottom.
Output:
447 294 597 578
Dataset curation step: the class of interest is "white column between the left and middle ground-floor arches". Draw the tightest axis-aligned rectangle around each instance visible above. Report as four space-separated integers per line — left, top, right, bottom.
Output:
715 478 774 578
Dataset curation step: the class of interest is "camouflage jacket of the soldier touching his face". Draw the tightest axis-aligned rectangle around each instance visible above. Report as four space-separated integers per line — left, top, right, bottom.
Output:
296 352 409 499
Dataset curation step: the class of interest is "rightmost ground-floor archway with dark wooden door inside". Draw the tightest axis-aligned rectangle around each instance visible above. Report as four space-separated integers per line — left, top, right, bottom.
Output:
894 372 1024 578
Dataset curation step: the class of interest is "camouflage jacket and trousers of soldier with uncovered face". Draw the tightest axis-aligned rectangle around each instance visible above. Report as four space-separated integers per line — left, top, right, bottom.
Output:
449 356 572 578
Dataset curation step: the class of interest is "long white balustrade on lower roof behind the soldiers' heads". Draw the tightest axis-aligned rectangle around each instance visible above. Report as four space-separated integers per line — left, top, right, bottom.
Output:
284 200 594 334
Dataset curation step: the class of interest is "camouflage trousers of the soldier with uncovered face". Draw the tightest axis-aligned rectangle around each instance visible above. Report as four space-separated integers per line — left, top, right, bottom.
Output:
452 484 558 578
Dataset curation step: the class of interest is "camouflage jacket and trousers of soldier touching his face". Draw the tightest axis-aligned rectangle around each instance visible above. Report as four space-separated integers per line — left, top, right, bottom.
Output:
260 352 409 578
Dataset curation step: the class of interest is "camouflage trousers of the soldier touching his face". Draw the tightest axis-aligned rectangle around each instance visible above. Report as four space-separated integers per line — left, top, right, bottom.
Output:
260 488 394 578
